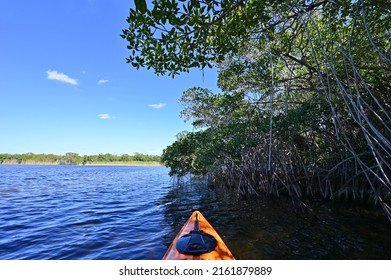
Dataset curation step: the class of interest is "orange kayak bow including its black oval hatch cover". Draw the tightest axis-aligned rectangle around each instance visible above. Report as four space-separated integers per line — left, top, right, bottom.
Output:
163 211 235 260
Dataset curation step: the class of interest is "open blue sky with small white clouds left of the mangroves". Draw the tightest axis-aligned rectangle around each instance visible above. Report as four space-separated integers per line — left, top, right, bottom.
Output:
0 0 217 155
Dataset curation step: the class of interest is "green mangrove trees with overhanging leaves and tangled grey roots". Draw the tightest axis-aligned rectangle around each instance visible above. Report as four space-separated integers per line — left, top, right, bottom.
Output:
122 0 391 219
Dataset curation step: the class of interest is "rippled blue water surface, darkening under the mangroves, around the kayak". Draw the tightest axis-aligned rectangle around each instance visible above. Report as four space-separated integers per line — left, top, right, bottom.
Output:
0 165 391 260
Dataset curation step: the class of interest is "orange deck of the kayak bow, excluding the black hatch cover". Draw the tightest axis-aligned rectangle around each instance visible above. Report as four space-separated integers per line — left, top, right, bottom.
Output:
163 211 235 260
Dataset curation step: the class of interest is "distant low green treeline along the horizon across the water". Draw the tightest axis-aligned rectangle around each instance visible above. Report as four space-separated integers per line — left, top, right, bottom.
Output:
0 153 160 165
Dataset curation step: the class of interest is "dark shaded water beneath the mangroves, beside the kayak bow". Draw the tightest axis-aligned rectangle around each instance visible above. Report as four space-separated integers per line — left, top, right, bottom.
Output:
161 179 391 260
